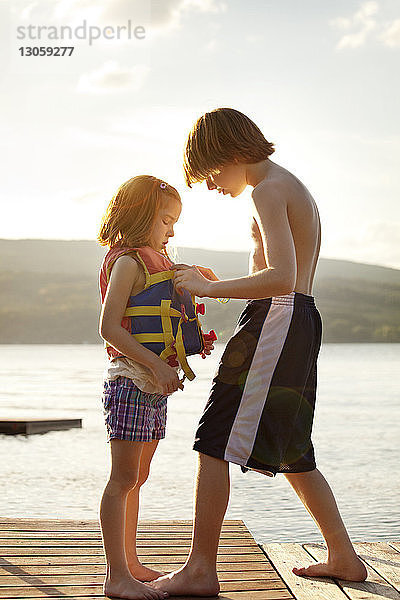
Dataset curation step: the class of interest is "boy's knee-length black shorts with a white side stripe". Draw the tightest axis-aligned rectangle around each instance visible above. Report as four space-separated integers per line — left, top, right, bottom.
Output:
194 292 322 475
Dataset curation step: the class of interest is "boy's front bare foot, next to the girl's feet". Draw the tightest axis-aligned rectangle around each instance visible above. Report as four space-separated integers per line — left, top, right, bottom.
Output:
150 567 220 597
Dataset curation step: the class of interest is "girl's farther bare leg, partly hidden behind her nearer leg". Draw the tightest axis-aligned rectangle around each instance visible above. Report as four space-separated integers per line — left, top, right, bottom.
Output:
125 440 163 581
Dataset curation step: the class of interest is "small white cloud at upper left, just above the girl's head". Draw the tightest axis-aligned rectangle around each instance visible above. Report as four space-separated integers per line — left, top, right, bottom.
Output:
77 60 150 94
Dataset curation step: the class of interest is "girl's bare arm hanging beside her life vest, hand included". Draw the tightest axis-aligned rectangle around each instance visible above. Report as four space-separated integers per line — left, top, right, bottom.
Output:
99 256 182 395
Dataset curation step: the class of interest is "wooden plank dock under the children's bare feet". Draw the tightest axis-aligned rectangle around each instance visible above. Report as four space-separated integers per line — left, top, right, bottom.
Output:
0 518 400 600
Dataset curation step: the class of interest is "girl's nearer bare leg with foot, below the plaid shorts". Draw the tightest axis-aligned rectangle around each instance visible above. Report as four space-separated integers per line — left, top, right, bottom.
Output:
100 439 168 600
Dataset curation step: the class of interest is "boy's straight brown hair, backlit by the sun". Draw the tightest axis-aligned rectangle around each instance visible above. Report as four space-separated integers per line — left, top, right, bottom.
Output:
183 108 274 187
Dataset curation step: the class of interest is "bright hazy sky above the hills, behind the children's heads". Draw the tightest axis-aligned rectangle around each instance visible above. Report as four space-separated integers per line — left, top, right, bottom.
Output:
0 0 400 268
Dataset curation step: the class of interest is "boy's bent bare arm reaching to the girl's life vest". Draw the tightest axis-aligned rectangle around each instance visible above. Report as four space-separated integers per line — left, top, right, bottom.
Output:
175 184 296 299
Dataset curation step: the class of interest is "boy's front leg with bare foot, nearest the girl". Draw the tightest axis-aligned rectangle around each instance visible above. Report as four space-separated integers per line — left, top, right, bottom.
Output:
152 453 229 596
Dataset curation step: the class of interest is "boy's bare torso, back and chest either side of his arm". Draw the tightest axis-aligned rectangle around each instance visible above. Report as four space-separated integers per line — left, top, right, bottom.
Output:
249 162 321 295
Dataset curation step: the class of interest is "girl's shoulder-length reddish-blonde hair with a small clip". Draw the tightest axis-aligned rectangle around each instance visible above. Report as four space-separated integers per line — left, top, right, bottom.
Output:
97 175 181 248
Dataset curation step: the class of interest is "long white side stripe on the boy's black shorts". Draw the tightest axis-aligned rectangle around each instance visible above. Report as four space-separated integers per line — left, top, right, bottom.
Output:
224 292 294 466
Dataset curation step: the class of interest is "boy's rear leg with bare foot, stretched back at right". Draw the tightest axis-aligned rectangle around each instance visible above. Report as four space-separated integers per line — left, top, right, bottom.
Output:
285 469 367 581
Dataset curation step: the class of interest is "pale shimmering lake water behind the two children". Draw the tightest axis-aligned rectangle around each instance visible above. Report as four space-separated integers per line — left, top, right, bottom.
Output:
0 344 400 543
